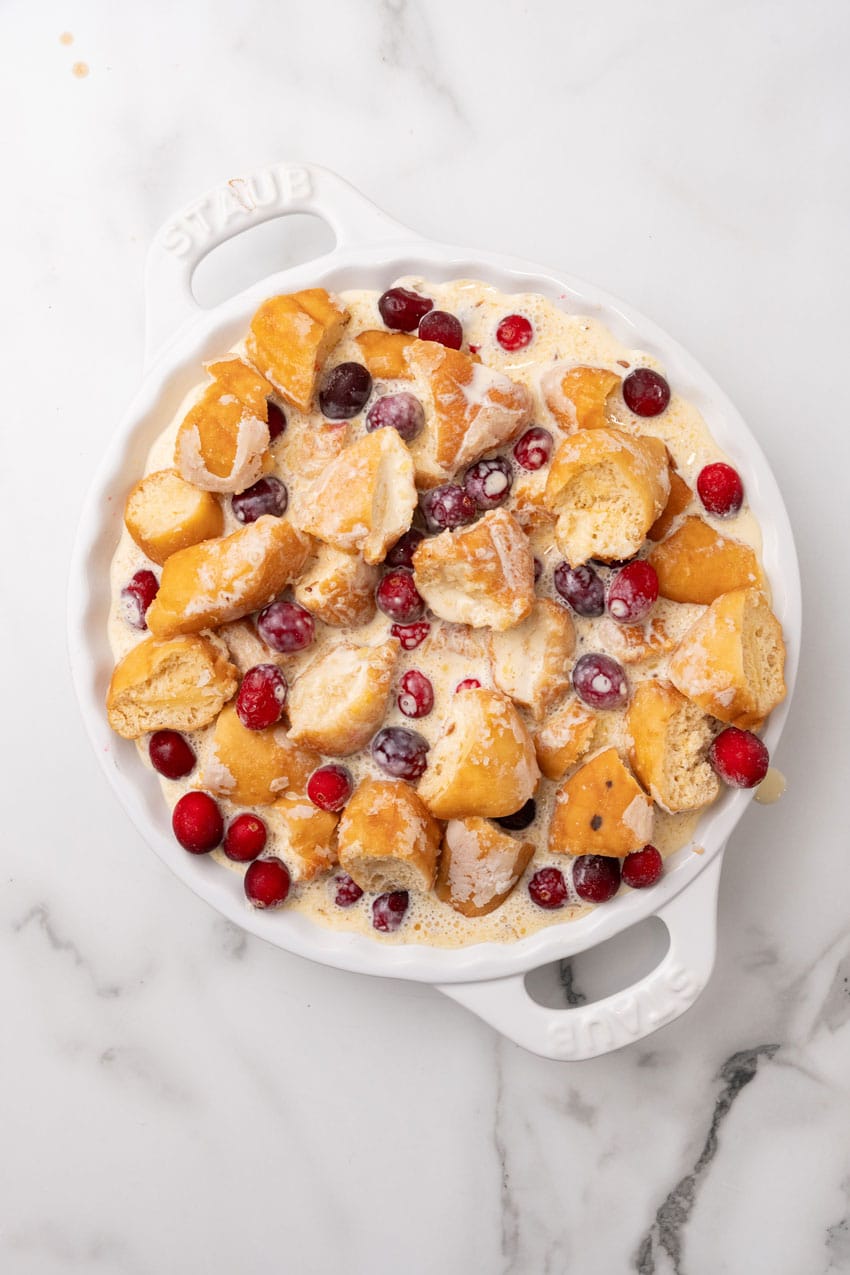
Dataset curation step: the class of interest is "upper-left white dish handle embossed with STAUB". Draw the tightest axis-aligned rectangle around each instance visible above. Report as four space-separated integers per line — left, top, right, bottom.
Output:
145 163 417 366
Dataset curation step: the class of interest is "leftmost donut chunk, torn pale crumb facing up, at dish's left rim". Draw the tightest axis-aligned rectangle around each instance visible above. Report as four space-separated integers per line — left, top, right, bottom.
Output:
106 636 237 740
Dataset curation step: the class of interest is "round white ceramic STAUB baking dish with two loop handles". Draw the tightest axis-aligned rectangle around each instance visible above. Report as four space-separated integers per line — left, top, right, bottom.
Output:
69 164 800 1060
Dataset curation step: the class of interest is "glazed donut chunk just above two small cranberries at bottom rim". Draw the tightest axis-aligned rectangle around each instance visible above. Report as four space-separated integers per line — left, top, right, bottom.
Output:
338 779 440 891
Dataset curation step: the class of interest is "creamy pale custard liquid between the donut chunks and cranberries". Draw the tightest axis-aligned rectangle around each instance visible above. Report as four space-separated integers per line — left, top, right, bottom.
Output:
108 278 761 946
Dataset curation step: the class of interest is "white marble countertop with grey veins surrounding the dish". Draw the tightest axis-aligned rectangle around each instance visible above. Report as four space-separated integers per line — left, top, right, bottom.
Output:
0 0 850 1275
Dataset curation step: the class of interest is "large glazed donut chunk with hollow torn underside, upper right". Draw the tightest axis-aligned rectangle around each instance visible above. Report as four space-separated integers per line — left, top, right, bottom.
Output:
545 430 670 566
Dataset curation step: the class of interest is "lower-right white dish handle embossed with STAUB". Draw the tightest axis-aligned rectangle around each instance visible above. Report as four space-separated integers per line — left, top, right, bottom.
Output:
438 849 723 1062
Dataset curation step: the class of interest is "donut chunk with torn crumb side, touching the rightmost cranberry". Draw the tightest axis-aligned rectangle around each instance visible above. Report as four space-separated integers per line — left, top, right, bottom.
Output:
627 680 720 815
